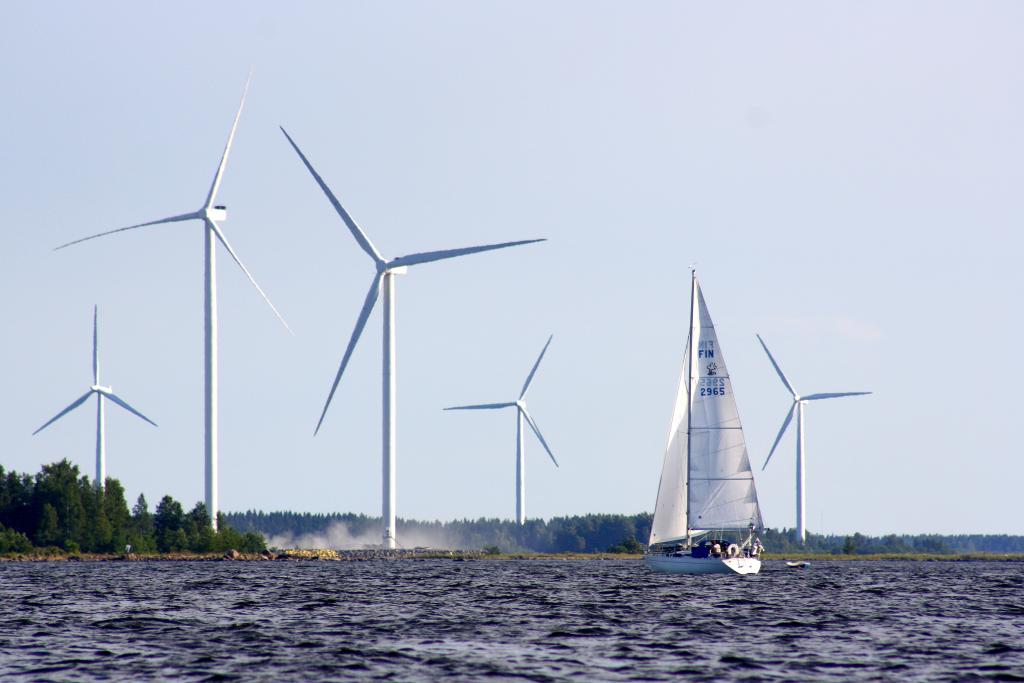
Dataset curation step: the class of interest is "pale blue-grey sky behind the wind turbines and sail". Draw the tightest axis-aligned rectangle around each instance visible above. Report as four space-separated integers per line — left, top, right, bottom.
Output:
0 1 1024 533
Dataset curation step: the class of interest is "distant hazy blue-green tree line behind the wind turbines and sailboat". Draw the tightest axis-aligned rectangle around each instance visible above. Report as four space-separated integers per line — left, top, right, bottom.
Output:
224 510 1024 555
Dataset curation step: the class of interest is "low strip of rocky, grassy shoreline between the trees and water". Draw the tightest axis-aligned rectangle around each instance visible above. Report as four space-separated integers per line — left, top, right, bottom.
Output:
0 548 1024 563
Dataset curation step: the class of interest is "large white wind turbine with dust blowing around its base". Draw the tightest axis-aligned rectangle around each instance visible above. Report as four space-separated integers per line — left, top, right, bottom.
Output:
281 127 544 549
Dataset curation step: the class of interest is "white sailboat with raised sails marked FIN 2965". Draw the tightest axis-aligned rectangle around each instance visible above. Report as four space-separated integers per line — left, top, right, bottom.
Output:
644 270 763 574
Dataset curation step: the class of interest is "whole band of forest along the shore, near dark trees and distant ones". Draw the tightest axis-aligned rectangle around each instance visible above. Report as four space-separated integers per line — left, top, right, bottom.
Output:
0 460 1024 555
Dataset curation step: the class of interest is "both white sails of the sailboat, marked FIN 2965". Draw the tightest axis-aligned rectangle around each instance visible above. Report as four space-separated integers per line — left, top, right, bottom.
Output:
650 273 762 545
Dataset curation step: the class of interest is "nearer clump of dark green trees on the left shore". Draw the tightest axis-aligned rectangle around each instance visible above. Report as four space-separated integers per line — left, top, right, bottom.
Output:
0 460 266 553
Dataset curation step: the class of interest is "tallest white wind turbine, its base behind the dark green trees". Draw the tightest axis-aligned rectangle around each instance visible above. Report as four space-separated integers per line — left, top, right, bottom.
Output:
57 75 291 530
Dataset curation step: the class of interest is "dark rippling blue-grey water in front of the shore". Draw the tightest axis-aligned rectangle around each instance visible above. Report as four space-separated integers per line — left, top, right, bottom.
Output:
0 560 1024 681
